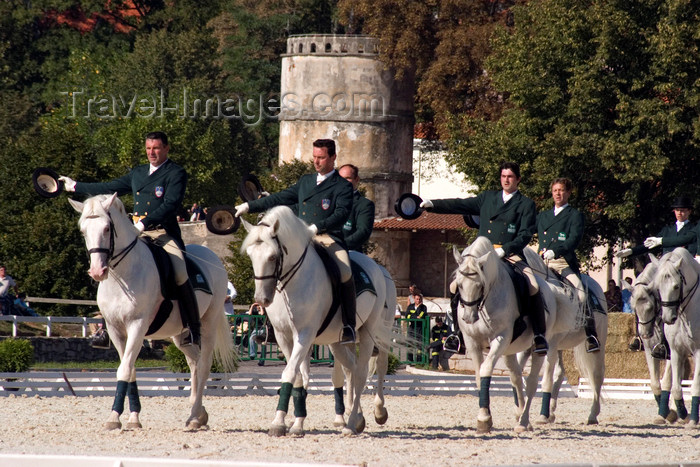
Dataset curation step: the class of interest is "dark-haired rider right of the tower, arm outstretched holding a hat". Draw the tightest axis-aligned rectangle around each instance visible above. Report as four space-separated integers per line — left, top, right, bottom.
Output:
420 162 549 355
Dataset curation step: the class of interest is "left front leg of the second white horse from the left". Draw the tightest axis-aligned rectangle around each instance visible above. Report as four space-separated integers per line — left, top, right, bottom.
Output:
268 335 312 436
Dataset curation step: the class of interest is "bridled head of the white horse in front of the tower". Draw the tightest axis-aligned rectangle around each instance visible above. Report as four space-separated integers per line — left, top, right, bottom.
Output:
241 206 312 307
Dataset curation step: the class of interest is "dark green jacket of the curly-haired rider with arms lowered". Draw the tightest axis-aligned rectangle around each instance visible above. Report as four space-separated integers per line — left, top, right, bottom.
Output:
537 206 585 273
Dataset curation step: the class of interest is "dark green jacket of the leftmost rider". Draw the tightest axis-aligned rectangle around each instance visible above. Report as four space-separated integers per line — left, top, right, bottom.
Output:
75 159 187 249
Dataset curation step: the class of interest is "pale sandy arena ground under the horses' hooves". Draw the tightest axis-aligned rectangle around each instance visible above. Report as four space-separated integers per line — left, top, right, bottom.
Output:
0 395 700 467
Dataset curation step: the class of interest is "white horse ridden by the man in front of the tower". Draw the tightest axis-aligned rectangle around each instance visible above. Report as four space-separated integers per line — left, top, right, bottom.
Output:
241 206 396 436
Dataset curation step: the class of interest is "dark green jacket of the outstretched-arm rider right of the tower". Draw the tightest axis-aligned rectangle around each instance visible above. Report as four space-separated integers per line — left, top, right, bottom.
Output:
431 191 537 257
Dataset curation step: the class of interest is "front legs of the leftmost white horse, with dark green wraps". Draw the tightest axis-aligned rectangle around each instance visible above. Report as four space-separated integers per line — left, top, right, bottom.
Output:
104 330 143 430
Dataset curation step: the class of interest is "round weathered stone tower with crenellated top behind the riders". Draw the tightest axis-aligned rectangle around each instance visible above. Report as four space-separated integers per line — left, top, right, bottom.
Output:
279 35 414 219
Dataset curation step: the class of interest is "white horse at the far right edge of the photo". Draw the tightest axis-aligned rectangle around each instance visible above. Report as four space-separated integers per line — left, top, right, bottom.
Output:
653 248 700 427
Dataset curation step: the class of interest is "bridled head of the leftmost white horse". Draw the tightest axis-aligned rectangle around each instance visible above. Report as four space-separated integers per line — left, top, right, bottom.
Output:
68 193 133 282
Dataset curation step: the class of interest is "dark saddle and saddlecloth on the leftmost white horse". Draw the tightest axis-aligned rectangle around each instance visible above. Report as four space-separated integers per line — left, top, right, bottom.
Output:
141 237 212 336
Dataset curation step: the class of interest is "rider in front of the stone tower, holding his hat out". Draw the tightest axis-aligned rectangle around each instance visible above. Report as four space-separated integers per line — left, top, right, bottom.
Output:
236 139 356 343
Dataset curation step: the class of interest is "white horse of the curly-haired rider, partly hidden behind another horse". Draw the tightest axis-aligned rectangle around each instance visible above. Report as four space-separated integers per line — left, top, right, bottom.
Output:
518 248 608 425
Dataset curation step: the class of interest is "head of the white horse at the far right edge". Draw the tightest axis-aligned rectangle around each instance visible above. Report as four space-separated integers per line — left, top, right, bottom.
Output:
654 248 700 324
